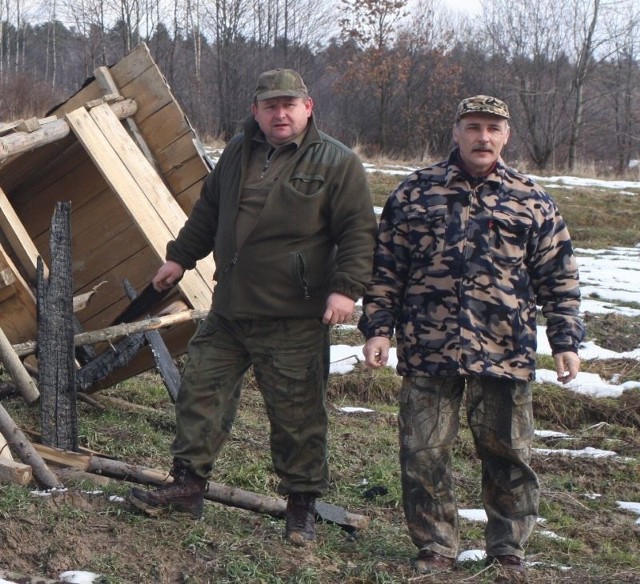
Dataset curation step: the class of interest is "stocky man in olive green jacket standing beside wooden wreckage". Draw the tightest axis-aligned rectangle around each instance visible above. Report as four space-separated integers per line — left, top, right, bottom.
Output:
130 69 376 545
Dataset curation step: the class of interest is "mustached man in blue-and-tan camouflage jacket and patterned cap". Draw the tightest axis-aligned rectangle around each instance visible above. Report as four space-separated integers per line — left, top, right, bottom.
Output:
359 96 584 581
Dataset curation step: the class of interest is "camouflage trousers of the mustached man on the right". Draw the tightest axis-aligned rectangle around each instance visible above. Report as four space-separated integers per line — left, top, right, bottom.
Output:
399 377 540 558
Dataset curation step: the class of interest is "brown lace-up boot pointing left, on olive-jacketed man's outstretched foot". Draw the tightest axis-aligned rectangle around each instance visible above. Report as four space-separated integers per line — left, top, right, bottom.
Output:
127 461 207 519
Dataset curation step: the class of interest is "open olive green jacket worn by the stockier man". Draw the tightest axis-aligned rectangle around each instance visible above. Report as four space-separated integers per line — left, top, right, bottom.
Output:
166 116 376 319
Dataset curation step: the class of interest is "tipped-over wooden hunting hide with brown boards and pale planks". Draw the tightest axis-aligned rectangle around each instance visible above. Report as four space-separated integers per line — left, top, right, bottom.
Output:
0 44 214 389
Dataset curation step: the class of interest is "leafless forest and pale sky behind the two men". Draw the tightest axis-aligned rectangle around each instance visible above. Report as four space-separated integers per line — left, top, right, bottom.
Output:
0 0 640 176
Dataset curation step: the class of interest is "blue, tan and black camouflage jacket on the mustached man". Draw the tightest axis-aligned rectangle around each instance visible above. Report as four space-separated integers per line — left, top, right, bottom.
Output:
359 150 584 380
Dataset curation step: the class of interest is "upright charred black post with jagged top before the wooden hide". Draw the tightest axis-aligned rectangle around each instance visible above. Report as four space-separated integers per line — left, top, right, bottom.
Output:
37 202 78 450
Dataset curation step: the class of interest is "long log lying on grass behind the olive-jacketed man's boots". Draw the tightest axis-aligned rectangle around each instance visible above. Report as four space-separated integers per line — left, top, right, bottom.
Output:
35 444 369 531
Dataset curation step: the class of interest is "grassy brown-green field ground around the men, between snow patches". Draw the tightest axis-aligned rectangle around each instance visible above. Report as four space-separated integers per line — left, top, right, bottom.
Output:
0 173 640 584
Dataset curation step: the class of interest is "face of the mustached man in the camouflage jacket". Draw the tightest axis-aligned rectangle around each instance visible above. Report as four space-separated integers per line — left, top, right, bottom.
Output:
453 113 509 176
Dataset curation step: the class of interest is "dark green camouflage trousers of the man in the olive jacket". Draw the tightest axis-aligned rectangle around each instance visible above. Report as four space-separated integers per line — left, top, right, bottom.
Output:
172 313 329 496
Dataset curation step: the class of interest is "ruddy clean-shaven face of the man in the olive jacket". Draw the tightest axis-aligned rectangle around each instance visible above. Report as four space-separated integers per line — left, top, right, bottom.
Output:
251 97 313 146
